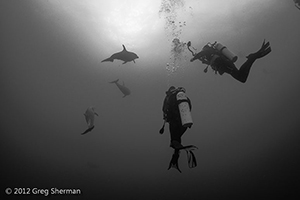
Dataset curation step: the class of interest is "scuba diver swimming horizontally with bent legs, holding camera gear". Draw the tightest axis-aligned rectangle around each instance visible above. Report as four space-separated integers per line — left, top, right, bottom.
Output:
187 40 271 83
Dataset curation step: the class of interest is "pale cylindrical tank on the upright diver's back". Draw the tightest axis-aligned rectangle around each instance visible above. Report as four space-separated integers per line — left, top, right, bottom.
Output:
176 90 193 128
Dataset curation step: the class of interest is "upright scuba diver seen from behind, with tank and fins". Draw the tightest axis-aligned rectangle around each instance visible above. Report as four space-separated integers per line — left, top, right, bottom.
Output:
159 86 197 173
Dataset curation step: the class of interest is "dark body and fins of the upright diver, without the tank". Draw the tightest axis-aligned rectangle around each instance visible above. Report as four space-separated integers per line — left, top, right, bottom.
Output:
160 86 197 172
